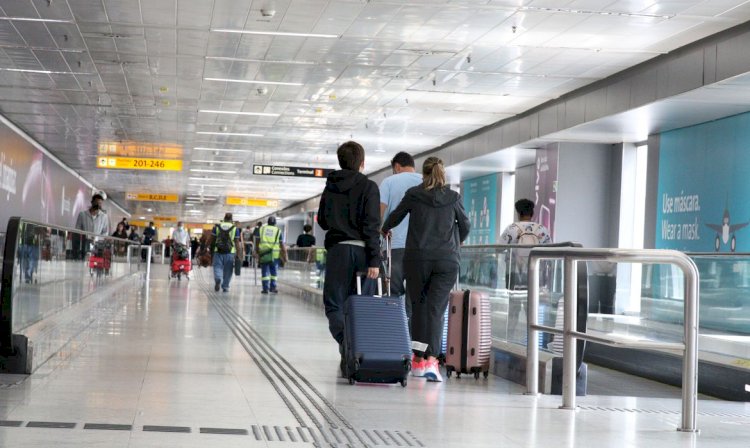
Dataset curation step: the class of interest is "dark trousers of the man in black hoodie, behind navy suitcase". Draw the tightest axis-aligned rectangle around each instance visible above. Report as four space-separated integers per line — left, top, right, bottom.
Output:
323 244 377 344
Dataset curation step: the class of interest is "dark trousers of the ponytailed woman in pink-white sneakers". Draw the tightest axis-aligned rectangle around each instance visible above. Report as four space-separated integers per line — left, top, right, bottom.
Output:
404 260 458 357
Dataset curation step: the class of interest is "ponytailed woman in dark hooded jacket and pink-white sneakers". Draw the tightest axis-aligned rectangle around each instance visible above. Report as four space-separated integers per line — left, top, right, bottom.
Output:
383 157 469 381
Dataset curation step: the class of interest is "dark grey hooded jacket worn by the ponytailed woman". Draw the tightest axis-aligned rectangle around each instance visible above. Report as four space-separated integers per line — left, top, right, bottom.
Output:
383 185 470 263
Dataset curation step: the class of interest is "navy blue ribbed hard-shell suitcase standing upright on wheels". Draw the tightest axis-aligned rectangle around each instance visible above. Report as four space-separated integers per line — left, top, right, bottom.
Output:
344 275 411 387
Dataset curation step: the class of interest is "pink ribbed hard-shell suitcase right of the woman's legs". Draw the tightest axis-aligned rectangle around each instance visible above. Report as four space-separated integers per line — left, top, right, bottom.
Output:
445 289 492 379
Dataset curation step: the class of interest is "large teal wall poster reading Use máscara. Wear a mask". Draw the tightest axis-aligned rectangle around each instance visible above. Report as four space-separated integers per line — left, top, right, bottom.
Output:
655 114 750 252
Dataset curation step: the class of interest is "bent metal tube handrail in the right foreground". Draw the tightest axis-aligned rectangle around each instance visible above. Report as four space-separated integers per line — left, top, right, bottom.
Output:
526 247 700 432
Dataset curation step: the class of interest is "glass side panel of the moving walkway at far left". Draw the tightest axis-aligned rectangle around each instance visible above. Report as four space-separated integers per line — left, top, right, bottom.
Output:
11 220 137 333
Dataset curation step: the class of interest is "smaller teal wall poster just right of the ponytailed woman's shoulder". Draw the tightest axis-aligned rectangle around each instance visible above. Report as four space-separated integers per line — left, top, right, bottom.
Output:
463 174 498 245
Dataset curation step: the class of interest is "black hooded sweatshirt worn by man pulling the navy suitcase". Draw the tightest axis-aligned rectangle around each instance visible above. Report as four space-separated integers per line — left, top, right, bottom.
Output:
318 170 380 268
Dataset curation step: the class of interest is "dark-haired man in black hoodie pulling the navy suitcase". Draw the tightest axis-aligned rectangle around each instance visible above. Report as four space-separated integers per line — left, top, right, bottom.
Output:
318 142 380 372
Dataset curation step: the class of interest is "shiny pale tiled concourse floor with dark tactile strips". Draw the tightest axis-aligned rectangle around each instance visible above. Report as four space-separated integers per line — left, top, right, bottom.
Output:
0 266 750 448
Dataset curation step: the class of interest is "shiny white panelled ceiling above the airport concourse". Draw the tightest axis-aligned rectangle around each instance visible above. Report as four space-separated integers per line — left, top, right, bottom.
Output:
0 0 750 217
